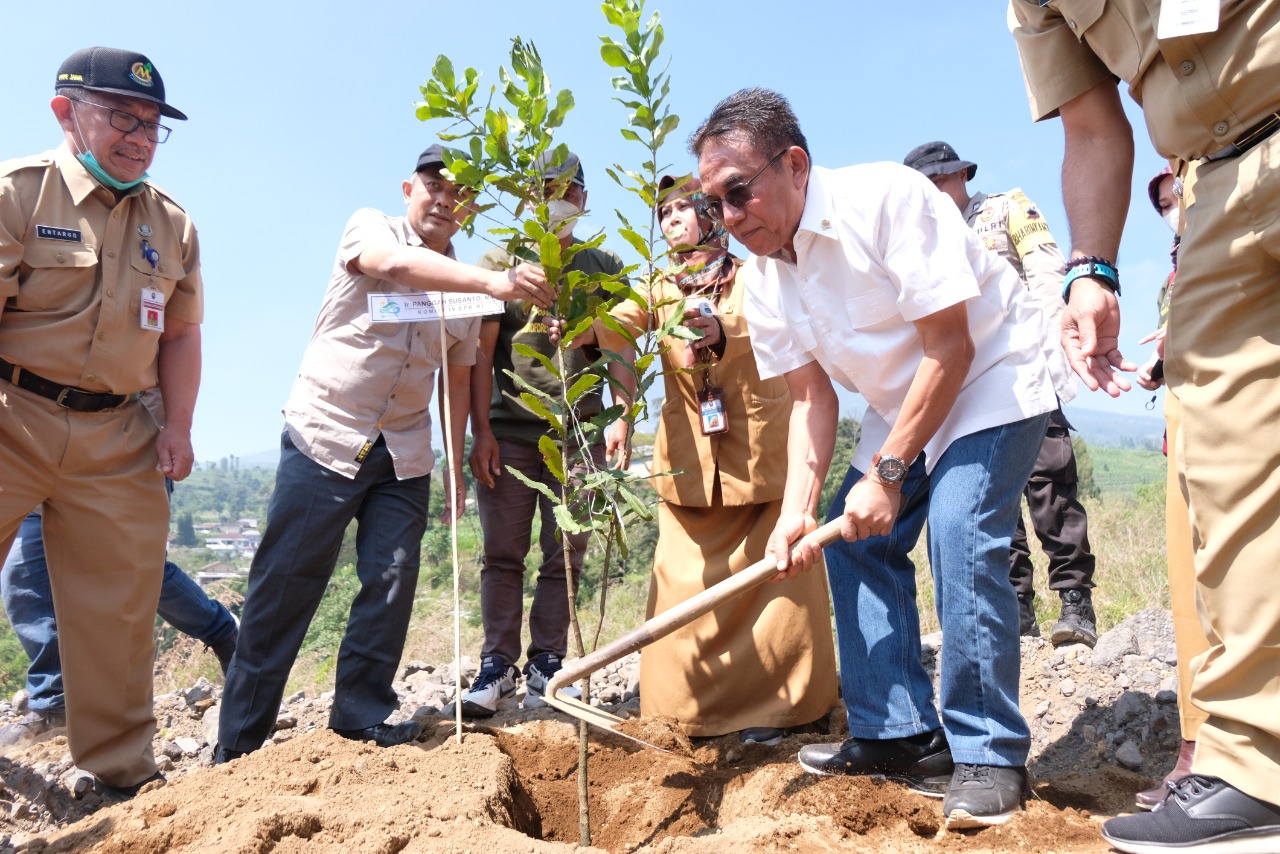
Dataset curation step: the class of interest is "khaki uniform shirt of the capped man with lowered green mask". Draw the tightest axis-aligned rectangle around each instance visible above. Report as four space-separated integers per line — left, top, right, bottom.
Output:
0 143 204 394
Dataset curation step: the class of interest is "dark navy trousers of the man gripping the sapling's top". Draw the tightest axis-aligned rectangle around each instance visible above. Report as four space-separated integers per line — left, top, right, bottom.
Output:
218 431 431 752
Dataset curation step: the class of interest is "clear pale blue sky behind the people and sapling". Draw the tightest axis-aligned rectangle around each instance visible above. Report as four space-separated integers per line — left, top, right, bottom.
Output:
0 0 1170 461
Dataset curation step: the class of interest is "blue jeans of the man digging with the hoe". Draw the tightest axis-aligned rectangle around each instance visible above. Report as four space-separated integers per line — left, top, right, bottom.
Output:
824 415 1048 767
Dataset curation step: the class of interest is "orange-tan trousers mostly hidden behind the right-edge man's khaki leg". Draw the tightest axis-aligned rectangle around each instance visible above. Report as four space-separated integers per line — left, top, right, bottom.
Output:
1165 391 1208 741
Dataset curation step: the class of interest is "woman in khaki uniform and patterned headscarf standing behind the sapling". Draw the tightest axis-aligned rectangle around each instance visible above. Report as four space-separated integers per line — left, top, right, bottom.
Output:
598 175 837 744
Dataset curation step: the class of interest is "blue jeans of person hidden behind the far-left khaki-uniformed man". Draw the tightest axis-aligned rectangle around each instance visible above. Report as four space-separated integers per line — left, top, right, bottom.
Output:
0 513 236 711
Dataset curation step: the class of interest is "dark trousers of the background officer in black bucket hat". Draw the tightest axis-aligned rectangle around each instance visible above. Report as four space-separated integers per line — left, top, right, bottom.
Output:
1009 410 1094 598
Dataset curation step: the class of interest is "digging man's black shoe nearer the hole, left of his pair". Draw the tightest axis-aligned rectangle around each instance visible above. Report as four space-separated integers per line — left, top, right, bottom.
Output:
800 730 954 798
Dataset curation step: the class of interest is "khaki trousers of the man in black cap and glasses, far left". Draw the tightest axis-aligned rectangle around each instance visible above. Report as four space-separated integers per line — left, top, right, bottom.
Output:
0 382 169 786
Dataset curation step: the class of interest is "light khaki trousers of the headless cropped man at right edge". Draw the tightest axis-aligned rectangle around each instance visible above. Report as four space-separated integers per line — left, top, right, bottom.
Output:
1165 134 1280 802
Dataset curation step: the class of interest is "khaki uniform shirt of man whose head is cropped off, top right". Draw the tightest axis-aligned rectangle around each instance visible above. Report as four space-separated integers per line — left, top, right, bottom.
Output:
1010 0 1280 160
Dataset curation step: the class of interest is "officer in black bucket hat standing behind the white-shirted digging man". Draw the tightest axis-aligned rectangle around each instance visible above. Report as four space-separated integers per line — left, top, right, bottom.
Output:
902 142 1098 647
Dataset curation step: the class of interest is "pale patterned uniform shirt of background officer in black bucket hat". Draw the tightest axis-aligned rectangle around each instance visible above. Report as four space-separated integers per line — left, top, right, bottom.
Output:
964 187 1065 329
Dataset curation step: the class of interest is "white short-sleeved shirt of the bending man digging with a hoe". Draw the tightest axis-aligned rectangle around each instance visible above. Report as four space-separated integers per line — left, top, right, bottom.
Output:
742 163 1075 471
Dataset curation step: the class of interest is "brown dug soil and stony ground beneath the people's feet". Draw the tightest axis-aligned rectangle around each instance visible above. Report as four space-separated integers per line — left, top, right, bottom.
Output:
0 612 1178 854
